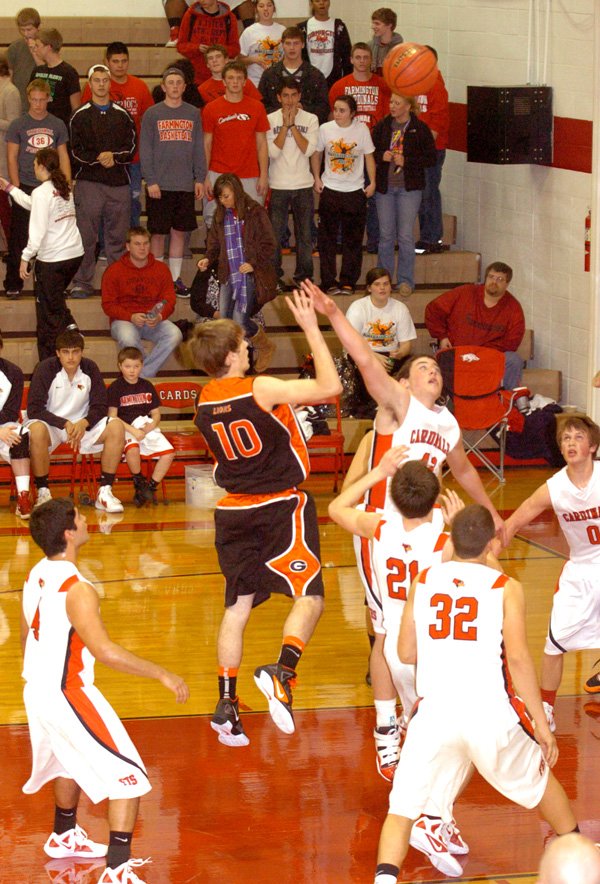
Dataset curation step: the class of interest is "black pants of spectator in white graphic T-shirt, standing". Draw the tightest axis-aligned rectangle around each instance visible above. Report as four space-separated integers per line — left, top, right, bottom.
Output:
319 187 367 291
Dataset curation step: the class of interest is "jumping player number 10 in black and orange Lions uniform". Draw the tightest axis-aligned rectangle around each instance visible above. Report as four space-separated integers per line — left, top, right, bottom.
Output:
191 292 341 746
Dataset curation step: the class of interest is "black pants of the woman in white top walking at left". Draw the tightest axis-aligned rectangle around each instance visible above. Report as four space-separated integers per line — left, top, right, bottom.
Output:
33 255 83 360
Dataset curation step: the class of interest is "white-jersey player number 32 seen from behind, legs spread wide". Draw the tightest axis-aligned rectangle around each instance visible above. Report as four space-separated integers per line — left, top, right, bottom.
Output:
375 505 578 884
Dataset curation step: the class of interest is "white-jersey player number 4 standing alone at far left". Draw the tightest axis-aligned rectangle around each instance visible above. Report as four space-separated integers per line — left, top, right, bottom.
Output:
21 499 189 884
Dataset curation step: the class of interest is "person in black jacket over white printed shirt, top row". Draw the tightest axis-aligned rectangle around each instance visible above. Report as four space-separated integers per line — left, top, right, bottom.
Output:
298 0 352 88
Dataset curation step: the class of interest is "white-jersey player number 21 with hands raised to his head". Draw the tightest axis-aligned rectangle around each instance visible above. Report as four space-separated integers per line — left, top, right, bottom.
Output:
329 447 468 876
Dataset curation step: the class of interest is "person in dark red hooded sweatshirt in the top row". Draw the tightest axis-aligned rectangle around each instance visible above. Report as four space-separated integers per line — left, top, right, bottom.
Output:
177 0 240 85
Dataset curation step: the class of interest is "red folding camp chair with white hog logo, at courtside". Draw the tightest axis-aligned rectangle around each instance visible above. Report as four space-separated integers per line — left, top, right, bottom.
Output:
436 346 515 482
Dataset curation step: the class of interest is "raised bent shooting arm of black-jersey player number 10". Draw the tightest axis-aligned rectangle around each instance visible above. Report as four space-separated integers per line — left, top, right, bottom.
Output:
254 291 342 410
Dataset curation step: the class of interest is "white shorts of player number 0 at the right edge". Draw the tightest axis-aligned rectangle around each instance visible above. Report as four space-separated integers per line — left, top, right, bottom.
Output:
544 562 600 655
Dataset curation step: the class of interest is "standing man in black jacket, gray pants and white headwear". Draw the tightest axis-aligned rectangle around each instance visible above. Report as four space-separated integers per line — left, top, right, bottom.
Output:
71 64 136 298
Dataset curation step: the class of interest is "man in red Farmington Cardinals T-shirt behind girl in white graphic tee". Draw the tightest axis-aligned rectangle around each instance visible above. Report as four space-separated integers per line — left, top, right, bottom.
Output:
329 43 391 255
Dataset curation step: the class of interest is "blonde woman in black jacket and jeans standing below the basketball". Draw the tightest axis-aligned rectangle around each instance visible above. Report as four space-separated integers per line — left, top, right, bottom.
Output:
371 94 437 298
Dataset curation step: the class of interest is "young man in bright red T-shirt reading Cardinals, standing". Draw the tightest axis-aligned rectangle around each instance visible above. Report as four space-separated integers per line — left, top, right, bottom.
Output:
202 61 271 227
